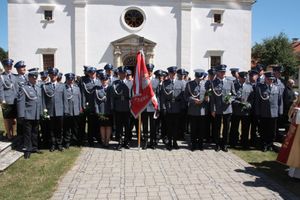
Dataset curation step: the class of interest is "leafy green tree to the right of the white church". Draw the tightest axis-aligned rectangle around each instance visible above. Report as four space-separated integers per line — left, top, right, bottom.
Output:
252 33 298 77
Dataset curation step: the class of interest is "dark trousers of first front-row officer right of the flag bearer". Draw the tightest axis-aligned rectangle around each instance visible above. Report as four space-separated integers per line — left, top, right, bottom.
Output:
166 113 180 143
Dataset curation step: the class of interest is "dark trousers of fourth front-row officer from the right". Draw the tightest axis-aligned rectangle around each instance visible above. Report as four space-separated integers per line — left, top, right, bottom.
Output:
189 116 208 146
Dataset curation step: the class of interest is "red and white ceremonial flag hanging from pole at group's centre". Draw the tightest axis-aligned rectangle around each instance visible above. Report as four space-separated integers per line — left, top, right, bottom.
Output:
131 51 158 118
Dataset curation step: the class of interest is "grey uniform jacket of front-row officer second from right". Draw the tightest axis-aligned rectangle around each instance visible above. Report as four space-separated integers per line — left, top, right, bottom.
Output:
232 81 255 116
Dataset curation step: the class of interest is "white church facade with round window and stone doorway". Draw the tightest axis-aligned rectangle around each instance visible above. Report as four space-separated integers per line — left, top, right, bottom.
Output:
8 0 254 74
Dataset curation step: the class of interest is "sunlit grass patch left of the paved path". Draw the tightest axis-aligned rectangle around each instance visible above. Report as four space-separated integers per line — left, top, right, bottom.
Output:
0 147 81 200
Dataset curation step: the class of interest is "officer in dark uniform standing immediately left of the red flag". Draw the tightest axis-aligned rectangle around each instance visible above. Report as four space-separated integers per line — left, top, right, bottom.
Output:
111 66 131 150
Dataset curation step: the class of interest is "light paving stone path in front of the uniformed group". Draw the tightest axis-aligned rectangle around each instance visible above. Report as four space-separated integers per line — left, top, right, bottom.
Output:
52 142 300 200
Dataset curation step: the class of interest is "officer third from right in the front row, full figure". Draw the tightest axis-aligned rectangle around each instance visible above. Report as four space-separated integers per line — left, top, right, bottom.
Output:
210 65 236 152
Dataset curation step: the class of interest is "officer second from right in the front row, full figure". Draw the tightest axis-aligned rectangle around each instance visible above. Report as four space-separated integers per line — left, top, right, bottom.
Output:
230 71 255 149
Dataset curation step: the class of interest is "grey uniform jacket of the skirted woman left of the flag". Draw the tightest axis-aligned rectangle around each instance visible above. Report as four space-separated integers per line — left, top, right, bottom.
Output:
93 86 112 114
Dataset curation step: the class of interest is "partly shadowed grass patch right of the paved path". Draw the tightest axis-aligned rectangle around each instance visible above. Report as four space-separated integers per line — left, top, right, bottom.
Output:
231 150 300 197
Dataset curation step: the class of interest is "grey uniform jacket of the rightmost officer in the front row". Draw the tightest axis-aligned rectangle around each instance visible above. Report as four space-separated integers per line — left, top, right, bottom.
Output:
255 84 282 118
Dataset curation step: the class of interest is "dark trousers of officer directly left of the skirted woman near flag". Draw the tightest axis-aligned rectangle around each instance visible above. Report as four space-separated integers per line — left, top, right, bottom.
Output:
88 113 101 145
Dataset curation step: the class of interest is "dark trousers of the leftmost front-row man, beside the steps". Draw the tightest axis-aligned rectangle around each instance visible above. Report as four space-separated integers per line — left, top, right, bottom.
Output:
23 120 39 152
